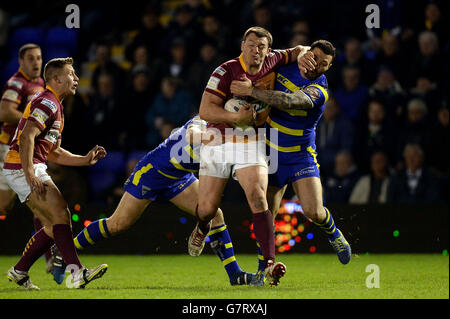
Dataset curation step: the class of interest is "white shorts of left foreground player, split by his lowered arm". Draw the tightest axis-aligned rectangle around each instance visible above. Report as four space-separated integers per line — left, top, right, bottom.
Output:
3 163 51 203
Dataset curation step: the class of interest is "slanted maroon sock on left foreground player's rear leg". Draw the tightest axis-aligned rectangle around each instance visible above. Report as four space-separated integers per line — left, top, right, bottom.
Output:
14 228 54 271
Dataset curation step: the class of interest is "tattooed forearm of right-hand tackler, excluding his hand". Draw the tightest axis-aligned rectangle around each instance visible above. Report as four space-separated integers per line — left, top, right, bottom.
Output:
251 87 314 110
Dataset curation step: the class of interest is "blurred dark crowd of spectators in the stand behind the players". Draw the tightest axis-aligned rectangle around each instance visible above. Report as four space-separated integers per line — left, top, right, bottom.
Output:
0 0 449 205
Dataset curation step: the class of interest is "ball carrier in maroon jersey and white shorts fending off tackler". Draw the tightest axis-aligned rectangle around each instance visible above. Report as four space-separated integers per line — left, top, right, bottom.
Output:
189 27 312 285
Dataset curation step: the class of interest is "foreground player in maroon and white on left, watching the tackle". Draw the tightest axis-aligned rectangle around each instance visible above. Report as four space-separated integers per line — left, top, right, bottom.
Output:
3 58 108 289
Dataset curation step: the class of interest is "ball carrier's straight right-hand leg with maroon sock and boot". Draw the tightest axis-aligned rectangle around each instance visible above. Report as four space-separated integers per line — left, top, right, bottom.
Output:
236 165 286 285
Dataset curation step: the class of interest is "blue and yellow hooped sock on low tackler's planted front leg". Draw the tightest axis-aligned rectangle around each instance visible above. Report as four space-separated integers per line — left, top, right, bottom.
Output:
208 224 242 280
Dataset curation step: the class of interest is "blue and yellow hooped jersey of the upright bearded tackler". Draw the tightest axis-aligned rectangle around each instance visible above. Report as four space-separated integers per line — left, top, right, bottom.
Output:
266 63 328 163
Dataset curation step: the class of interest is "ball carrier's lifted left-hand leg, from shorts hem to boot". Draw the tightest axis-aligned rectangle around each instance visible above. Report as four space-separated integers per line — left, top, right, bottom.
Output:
188 175 228 257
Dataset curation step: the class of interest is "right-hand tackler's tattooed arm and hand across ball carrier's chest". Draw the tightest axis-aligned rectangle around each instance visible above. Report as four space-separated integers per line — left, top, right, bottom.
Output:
230 76 314 110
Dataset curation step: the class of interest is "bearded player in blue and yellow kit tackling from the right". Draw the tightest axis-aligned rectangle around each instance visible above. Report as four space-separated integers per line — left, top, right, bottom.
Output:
231 40 351 264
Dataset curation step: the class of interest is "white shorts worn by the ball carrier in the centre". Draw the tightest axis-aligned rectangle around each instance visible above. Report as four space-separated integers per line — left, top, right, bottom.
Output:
199 141 267 180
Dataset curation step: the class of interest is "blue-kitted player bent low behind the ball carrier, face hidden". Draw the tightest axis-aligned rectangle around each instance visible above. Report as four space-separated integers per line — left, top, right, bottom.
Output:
68 116 264 286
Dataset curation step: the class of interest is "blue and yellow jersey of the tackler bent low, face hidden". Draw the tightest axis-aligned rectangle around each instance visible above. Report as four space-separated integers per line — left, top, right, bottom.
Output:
142 116 206 179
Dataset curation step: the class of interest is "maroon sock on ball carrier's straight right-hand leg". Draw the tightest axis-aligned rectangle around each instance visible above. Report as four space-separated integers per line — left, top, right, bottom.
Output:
253 210 275 263
